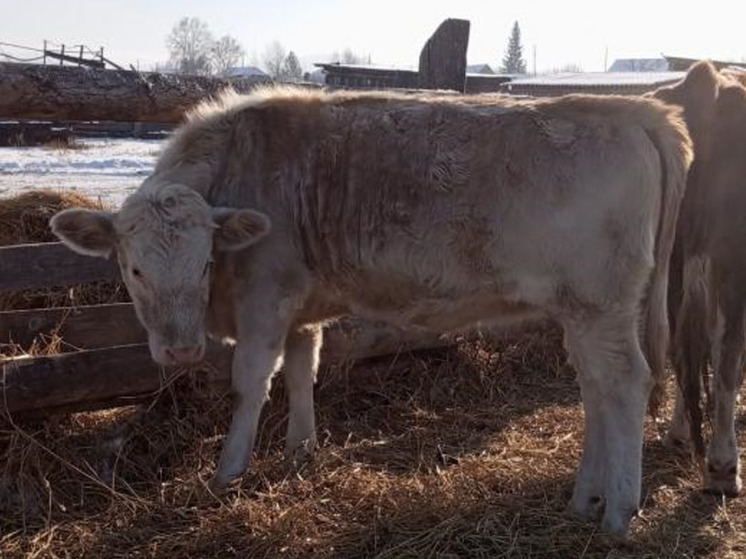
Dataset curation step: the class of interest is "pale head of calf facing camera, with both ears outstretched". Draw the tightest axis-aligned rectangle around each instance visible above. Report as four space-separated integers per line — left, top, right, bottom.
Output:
51 184 270 365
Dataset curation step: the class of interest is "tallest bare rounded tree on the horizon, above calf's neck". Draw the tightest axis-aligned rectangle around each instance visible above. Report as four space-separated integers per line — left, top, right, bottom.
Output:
166 17 213 76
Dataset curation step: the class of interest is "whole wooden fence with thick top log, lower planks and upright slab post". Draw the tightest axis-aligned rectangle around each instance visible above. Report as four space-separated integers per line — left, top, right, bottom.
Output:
0 20 469 414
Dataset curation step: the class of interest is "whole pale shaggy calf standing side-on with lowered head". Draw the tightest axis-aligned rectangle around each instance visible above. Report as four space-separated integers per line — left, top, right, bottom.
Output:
52 86 690 533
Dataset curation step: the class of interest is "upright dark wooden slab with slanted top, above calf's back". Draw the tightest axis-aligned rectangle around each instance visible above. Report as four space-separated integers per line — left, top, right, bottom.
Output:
419 19 470 93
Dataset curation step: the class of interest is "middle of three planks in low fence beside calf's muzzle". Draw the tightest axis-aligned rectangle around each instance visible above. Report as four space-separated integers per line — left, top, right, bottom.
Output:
0 303 142 349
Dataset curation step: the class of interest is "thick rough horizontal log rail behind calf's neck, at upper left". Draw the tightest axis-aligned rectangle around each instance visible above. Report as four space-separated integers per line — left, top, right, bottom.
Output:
0 63 271 122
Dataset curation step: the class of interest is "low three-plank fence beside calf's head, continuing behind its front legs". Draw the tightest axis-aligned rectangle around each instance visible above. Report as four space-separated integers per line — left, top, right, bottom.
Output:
0 243 446 415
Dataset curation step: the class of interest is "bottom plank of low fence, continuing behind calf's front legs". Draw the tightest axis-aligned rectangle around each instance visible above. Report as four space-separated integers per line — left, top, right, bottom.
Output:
0 321 449 415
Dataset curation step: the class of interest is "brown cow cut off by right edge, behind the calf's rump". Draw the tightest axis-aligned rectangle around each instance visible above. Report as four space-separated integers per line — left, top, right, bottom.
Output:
656 62 746 495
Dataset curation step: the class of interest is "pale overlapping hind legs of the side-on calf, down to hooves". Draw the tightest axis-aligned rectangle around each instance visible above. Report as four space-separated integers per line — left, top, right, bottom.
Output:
563 313 652 535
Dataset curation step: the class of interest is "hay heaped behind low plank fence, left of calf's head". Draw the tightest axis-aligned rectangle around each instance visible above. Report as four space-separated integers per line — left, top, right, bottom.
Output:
0 190 127 320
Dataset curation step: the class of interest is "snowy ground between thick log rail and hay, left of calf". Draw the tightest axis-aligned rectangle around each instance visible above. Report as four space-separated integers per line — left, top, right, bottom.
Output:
0 139 163 206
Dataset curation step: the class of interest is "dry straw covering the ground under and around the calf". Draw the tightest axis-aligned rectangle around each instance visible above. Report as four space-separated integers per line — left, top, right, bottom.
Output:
0 329 746 559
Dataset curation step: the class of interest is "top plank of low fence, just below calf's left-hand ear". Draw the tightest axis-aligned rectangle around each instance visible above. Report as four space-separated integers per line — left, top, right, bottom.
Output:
0 243 119 289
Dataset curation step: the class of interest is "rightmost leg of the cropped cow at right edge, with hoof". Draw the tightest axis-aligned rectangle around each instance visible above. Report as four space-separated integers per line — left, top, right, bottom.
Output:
706 284 746 495
